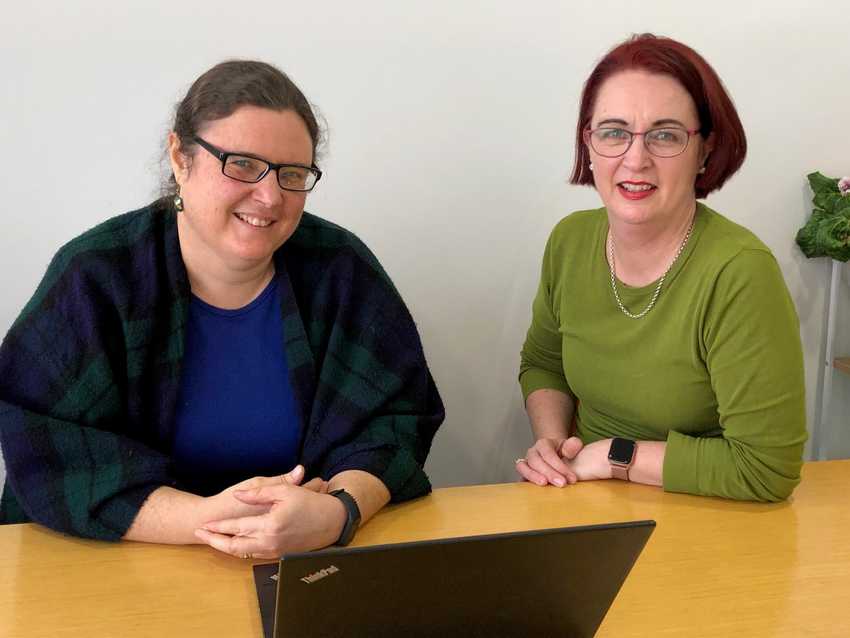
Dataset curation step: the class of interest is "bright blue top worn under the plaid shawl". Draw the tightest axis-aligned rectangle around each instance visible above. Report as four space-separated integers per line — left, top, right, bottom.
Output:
172 278 301 493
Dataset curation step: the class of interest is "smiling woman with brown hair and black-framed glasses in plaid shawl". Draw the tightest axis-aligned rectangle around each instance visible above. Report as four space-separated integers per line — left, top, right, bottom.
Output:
0 61 444 558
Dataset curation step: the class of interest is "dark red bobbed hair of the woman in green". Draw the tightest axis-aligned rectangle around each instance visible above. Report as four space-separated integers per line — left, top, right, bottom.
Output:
570 33 747 198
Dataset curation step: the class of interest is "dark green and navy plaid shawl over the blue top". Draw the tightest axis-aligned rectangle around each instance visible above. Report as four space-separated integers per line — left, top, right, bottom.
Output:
0 202 444 540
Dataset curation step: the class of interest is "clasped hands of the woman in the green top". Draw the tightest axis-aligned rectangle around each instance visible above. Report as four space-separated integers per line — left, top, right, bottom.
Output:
516 436 611 487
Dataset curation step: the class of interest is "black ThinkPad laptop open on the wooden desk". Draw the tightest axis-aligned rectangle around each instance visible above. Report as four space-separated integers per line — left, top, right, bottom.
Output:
254 521 655 638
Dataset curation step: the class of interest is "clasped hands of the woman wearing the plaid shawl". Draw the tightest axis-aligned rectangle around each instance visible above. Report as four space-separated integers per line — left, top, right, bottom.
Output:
195 465 345 559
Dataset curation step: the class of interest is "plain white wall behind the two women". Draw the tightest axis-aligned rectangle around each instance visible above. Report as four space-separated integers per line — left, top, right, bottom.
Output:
0 0 850 485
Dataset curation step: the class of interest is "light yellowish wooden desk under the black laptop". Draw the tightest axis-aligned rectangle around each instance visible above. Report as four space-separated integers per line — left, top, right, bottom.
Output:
0 461 850 638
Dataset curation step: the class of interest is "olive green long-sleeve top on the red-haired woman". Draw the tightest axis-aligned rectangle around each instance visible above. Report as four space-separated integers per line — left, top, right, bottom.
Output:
520 204 806 501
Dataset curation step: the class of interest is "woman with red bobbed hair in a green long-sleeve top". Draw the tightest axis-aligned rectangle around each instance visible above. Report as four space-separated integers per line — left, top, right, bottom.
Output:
516 34 806 501
